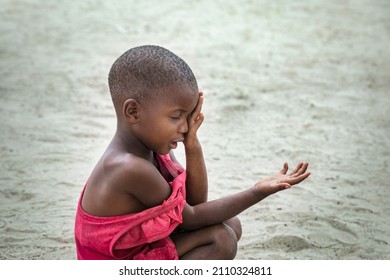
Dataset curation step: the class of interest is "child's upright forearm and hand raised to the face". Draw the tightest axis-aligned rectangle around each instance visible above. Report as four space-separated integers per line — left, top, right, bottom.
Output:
184 93 208 205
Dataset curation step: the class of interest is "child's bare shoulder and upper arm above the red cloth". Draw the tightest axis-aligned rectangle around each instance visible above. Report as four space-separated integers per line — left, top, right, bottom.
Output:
82 154 171 216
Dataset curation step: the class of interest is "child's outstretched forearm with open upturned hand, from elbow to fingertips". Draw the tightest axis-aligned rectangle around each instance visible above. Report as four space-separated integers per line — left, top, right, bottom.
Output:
181 163 310 230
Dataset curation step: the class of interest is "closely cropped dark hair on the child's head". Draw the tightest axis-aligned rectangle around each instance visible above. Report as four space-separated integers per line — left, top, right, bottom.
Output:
108 45 198 107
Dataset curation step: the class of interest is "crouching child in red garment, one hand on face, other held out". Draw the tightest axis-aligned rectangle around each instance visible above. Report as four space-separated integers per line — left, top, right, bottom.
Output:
75 46 310 259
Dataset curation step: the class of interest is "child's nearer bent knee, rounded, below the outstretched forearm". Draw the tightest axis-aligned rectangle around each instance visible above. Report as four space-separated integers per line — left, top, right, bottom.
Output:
214 224 238 260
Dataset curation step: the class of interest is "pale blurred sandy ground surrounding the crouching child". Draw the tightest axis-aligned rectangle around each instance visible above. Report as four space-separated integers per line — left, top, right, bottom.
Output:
0 0 390 260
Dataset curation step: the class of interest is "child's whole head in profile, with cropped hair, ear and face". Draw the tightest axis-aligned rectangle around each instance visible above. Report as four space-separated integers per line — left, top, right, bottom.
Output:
108 46 199 154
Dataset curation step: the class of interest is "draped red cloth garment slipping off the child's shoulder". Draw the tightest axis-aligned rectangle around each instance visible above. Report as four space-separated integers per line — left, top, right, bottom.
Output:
75 155 186 260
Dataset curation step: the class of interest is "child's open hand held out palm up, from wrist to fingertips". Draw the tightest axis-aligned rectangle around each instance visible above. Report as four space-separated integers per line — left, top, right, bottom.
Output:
255 163 310 196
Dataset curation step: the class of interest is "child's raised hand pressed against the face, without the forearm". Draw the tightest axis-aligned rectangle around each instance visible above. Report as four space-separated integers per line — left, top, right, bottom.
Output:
183 92 204 149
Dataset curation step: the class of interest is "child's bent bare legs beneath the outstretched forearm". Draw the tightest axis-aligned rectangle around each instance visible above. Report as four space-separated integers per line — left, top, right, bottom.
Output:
171 218 241 260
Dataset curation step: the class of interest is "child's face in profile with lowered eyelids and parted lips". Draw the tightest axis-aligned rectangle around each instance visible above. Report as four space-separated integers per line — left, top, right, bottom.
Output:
138 86 199 155
